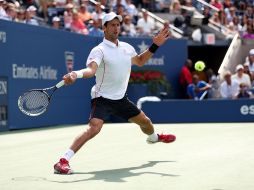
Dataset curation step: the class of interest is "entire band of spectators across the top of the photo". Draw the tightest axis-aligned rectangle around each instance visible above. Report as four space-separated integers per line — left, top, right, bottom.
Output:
0 0 254 39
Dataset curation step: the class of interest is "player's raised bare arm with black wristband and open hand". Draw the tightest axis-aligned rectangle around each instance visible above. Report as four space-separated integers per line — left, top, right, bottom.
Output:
132 24 170 67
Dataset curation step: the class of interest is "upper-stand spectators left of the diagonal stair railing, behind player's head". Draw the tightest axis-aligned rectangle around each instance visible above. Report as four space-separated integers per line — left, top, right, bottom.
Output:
0 0 159 37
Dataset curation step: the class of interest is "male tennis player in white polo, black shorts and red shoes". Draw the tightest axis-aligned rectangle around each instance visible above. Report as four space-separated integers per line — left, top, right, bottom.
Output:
54 12 176 174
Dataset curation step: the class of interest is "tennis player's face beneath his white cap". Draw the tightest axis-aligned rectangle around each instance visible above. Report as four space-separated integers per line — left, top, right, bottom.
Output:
104 18 121 42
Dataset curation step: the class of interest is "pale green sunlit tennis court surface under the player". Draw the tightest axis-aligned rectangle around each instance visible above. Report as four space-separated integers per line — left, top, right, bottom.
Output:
0 123 254 190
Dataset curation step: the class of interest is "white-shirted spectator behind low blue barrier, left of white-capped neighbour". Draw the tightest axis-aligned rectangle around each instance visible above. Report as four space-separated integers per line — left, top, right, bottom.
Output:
220 71 239 99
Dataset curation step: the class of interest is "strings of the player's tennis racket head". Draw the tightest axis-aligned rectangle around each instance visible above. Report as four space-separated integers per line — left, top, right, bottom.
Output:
19 91 49 115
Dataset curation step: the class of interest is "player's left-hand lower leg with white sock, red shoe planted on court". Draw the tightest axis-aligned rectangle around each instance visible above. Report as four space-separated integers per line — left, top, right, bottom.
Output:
54 118 104 174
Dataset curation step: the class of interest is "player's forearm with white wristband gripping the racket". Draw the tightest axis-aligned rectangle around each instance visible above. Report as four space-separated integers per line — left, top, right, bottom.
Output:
63 62 98 85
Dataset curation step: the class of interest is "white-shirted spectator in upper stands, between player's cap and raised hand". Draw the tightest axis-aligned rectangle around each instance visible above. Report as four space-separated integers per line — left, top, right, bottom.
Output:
137 11 155 36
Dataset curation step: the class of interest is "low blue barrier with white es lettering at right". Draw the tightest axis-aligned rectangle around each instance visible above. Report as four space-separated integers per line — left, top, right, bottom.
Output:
142 99 254 123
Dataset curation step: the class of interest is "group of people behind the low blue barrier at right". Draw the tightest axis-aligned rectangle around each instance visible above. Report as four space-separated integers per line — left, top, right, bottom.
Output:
179 49 254 99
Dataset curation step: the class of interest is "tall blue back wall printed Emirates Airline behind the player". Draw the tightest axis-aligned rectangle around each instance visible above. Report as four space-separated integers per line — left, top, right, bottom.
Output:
0 20 187 129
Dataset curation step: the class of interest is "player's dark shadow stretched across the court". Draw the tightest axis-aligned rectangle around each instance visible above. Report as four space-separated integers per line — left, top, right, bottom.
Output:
47 161 179 183
